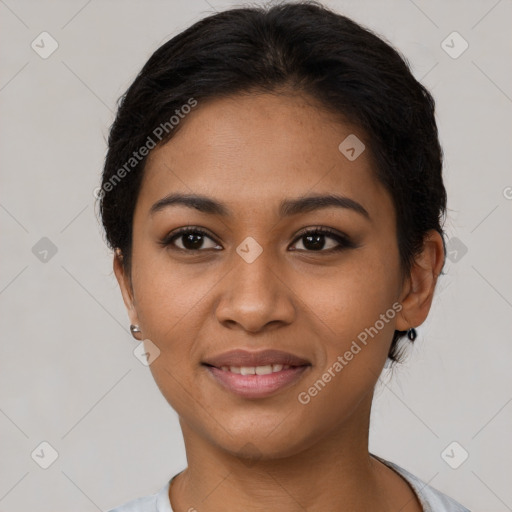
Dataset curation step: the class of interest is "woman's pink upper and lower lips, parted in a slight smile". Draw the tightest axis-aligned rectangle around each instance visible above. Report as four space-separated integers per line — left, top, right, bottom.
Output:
203 350 311 399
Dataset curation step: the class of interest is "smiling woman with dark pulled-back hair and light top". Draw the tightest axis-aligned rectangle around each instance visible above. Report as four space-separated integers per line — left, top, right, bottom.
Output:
100 2 467 512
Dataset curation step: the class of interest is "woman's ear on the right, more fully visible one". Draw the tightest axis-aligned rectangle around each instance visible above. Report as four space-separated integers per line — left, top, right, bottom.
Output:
395 229 445 331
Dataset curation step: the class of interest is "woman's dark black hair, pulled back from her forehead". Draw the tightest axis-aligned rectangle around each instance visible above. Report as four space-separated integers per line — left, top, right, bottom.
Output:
99 1 446 362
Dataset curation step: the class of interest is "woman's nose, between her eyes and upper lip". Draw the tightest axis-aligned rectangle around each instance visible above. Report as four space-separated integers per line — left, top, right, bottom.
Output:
215 250 296 333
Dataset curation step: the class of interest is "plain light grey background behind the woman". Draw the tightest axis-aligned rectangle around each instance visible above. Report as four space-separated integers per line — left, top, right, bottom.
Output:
0 0 512 512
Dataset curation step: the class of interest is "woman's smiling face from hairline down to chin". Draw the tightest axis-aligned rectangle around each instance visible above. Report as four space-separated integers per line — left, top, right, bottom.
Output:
114 94 440 458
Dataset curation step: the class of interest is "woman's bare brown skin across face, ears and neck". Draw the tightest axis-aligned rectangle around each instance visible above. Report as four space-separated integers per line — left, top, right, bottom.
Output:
114 93 444 512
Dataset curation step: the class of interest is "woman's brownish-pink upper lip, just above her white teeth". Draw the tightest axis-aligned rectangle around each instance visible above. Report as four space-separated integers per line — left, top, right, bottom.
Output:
203 349 311 368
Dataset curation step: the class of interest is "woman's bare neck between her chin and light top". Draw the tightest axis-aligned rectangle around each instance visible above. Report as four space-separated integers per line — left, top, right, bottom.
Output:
166 396 414 512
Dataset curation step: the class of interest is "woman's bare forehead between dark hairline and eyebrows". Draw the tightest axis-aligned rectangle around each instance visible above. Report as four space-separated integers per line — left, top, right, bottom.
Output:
137 94 392 224
